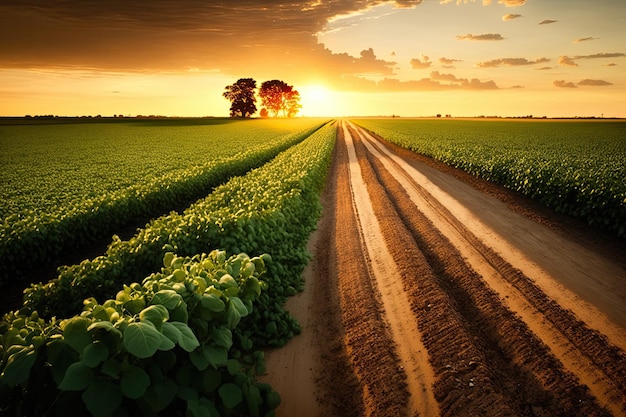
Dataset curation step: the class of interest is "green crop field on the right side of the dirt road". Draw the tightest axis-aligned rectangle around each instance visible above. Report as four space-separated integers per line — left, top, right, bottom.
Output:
357 120 626 236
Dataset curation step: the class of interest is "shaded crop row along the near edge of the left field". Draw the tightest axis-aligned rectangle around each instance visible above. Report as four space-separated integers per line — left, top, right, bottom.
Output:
0 121 320 287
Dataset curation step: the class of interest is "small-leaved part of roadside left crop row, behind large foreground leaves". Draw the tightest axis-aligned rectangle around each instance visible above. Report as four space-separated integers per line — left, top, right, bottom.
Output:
19 118 336 346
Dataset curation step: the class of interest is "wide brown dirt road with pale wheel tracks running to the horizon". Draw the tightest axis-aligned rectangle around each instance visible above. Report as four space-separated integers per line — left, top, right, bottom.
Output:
265 118 626 417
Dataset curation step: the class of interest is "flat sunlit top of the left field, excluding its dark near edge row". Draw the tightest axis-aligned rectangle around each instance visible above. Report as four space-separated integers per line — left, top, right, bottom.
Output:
0 119 320 219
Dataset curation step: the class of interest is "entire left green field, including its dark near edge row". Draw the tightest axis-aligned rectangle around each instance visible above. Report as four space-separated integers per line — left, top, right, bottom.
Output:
0 119 330 287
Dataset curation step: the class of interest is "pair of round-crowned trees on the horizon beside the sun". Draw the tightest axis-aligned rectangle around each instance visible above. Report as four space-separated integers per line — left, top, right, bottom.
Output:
223 78 302 118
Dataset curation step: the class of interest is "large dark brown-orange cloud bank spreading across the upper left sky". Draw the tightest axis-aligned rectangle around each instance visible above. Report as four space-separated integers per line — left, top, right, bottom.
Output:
0 0 404 81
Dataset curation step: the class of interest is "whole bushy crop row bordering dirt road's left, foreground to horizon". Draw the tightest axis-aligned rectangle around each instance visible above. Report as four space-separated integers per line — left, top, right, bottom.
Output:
0 123 336 417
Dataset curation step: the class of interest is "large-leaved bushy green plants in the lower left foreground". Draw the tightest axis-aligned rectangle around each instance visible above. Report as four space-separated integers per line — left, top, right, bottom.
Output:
0 251 280 417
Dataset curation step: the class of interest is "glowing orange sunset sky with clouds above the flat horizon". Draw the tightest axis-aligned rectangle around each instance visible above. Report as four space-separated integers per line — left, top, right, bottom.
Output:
0 0 626 117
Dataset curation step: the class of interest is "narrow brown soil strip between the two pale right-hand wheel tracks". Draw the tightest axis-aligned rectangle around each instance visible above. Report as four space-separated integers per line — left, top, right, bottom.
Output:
354 122 626 415
